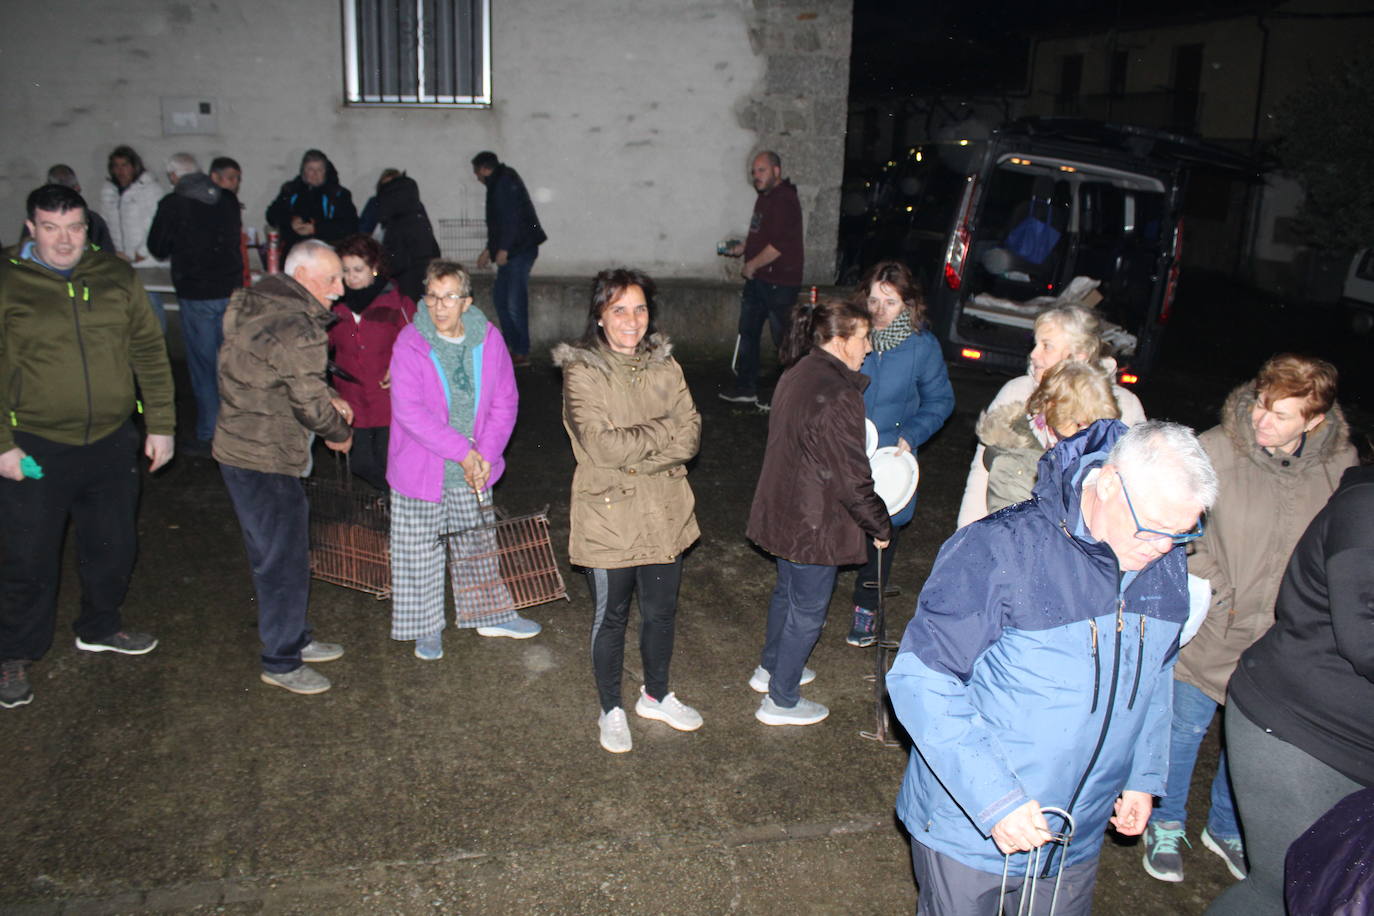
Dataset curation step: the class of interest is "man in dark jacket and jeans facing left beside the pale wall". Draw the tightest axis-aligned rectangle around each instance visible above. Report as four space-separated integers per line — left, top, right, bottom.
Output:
473 151 548 367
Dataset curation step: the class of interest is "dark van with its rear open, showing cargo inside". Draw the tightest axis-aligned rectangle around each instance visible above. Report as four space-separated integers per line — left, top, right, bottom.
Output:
915 118 1254 383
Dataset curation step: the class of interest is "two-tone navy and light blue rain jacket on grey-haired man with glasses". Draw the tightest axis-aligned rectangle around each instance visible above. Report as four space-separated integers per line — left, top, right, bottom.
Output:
888 420 1189 875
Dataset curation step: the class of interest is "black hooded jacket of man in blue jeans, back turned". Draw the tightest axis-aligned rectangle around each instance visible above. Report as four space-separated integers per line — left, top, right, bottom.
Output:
148 172 243 299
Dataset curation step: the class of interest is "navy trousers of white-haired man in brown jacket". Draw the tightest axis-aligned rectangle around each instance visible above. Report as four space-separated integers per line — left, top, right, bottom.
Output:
220 464 311 674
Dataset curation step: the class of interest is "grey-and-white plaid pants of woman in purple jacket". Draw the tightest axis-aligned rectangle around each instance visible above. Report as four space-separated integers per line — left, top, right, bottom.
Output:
392 486 517 640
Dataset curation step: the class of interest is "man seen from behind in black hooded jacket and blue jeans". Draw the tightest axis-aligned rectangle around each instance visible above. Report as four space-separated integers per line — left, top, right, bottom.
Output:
148 152 243 456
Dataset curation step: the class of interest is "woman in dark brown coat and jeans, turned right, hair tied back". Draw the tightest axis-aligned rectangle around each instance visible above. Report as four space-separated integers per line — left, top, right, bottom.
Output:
747 299 892 725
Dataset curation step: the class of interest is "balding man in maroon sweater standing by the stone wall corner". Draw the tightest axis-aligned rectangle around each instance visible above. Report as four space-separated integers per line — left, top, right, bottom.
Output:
720 150 804 404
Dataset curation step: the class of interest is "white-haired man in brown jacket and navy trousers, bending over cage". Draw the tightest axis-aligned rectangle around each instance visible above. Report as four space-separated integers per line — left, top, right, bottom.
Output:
214 240 353 694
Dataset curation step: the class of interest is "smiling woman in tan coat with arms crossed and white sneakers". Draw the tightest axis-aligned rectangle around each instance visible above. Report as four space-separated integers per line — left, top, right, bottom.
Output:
554 268 701 754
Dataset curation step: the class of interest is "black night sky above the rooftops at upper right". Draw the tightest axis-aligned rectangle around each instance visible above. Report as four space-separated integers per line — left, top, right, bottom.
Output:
851 0 1278 96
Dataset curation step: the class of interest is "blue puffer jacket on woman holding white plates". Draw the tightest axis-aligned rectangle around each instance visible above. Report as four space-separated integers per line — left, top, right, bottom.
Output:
859 328 954 525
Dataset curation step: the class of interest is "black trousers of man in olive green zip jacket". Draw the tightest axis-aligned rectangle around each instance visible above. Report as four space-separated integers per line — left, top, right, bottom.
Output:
0 423 139 661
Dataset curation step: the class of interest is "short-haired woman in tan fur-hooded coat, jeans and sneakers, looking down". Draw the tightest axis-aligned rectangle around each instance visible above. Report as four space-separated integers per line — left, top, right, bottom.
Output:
1145 354 1356 882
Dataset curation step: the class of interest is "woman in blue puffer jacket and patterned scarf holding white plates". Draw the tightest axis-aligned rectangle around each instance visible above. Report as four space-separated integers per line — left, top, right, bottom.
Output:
845 261 954 647
